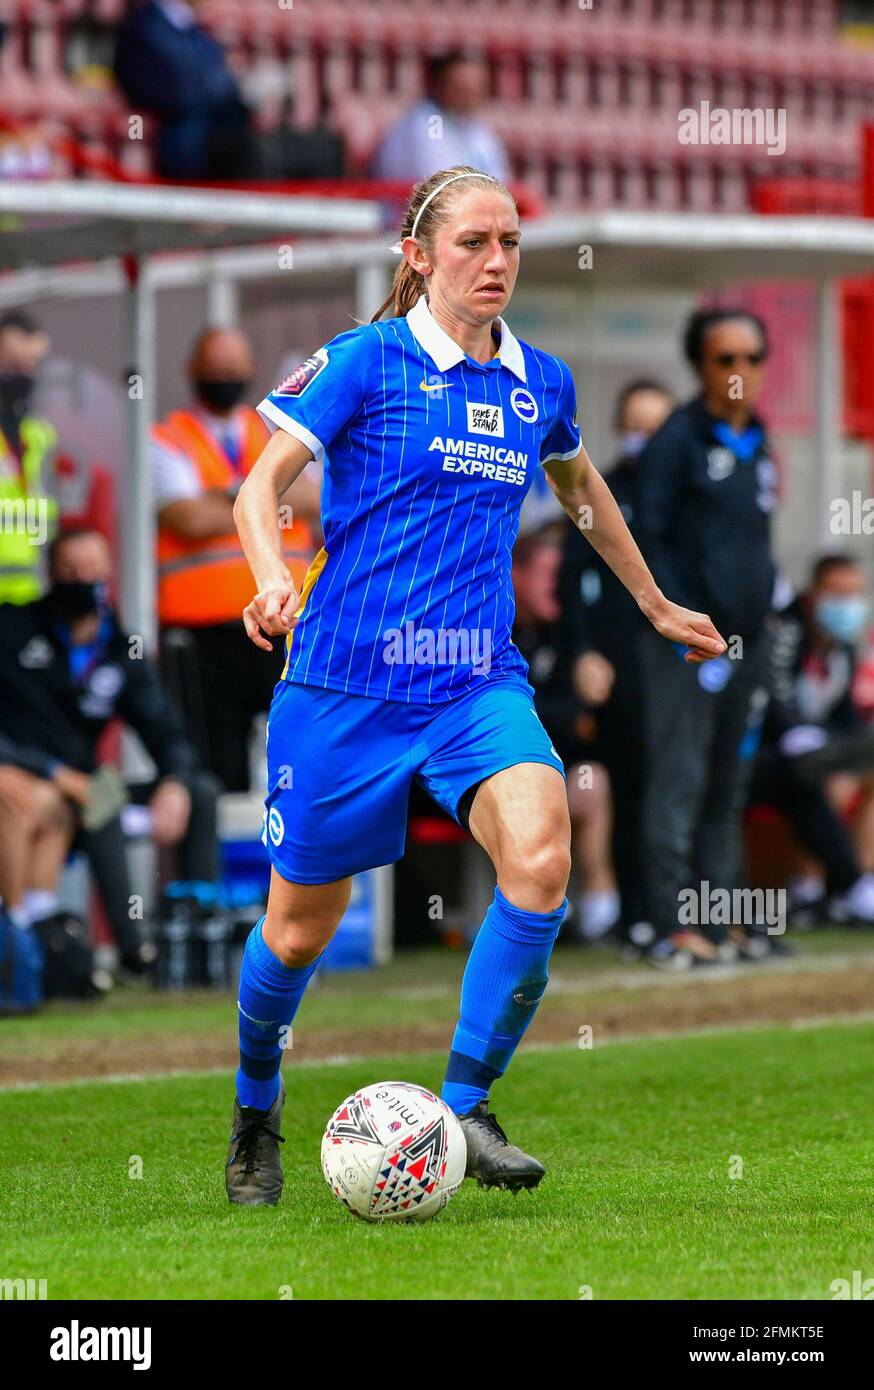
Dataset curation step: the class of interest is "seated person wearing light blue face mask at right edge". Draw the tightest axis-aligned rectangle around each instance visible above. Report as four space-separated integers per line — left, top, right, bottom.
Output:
750 555 874 923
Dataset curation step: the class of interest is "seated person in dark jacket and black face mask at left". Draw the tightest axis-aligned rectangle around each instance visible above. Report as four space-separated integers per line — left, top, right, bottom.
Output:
0 530 218 972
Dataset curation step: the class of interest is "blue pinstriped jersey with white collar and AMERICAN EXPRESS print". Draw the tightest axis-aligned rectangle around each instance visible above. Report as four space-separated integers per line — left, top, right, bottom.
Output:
258 295 582 703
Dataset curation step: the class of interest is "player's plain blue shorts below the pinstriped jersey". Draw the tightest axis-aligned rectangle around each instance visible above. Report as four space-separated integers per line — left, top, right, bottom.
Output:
261 676 564 883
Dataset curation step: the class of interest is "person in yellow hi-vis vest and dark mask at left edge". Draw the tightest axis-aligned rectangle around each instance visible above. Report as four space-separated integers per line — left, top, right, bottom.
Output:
0 310 57 603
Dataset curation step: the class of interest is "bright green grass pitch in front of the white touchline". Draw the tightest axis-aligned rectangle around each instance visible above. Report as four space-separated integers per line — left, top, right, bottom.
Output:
0 1022 874 1300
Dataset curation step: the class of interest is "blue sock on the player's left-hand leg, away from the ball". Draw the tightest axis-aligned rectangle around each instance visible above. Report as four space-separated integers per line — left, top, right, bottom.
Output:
236 917 321 1111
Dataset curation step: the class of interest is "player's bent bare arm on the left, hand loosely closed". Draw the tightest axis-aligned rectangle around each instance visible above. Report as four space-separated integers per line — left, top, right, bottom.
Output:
233 430 313 652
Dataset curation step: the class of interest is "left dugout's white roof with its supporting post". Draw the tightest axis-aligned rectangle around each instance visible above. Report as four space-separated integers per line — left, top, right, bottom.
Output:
0 181 381 646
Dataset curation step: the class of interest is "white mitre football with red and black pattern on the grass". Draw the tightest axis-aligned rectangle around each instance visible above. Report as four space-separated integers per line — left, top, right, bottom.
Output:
322 1081 467 1220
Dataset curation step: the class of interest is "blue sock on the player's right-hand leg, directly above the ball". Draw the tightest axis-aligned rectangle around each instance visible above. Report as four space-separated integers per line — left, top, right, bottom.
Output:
440 887 567 1115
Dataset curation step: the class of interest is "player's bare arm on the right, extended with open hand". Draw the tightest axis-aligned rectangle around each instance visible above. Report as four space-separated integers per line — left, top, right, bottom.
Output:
543 446 727 664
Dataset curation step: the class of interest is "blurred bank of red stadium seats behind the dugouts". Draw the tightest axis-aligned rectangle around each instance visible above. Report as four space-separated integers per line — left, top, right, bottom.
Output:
0 0 874 209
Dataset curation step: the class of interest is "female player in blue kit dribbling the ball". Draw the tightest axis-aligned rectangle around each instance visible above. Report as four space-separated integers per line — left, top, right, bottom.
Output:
225 167 725 1205
